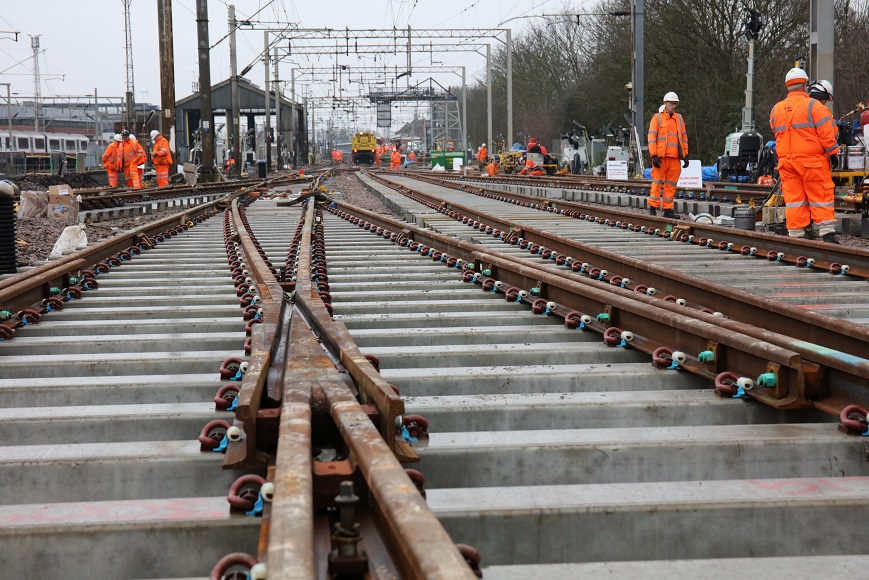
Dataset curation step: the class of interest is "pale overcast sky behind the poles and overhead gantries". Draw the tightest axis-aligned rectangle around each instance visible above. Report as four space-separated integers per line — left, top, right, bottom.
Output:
0 0 593 129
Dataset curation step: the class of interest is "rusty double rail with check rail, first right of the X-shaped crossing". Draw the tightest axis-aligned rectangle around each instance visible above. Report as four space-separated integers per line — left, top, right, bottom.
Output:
326 202 869 413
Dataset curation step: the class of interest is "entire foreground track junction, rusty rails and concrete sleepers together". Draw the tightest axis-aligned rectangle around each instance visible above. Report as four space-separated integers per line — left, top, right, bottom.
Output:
0 168 869 578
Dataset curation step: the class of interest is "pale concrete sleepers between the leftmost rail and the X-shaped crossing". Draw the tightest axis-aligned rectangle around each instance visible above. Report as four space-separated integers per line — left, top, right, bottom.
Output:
0 194 259 578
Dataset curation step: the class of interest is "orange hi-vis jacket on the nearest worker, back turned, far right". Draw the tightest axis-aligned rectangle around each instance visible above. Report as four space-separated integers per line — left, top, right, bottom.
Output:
769 91 839 159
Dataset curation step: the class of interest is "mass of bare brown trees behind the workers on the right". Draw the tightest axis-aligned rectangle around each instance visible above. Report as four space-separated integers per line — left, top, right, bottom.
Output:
468 0 869 164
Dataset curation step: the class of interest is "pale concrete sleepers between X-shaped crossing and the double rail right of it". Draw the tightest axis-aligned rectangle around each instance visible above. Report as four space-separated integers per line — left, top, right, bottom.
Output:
316 198 866 578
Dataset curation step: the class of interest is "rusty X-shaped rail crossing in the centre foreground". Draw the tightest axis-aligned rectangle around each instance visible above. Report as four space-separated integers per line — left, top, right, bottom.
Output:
224 187 473 579
